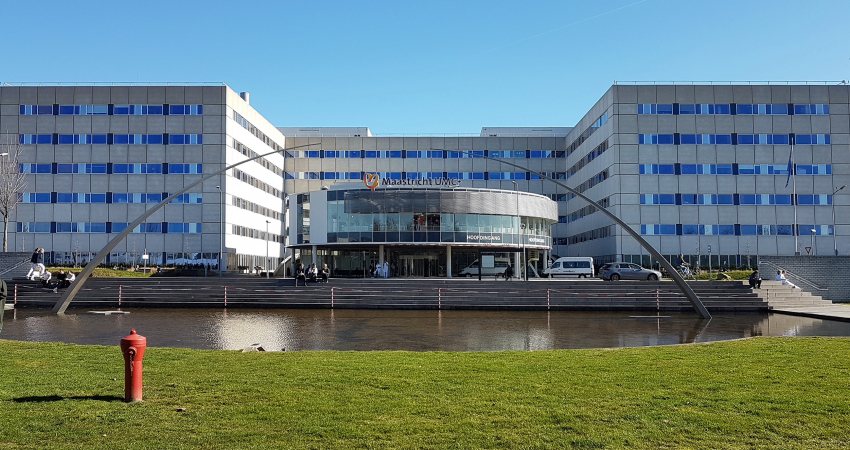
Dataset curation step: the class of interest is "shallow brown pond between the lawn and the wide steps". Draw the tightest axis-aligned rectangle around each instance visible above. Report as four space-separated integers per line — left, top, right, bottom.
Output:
2 309 850 351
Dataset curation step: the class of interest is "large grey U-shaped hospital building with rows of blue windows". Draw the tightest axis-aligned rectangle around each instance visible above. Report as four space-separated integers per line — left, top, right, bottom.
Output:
0 82 850 275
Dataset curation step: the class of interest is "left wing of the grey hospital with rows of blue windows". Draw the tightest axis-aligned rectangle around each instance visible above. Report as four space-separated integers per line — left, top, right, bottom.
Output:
0 83 285 270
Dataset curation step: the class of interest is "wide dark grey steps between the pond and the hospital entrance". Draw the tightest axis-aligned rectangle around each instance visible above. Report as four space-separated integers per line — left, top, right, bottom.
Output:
3 276 768 311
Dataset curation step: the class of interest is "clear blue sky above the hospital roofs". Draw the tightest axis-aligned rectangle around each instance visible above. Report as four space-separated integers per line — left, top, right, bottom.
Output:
0 0 850 135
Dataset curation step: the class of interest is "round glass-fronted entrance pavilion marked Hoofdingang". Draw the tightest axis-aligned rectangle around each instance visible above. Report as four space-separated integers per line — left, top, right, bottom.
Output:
290 185 557 277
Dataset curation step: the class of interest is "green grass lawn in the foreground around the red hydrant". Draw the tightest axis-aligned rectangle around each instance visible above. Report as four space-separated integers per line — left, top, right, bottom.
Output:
0 336 850 449
